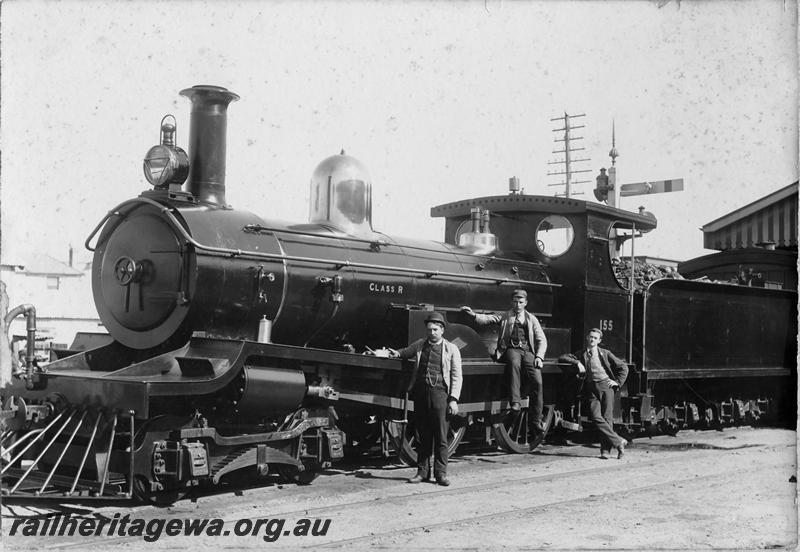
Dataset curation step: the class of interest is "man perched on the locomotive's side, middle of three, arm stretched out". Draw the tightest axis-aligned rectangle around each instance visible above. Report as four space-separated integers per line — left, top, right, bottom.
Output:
461 289 547 438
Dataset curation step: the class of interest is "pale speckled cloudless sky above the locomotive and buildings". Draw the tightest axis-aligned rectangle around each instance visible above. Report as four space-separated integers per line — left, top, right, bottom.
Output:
0 0 798 268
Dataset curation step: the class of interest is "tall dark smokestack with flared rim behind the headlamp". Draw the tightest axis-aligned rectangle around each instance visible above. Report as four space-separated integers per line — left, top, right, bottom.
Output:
181 85 239 206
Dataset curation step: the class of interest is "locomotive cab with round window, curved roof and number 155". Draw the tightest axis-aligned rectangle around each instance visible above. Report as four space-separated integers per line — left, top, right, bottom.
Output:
431 194 657 356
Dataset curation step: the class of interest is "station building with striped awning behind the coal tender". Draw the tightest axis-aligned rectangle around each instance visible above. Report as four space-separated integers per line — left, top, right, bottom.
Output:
678 182 798 289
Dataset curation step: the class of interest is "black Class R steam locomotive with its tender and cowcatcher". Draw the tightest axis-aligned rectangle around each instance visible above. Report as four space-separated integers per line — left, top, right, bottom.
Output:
0 86 797 501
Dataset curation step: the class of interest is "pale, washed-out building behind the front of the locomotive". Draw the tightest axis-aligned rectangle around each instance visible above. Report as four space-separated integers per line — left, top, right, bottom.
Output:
0 248 105 360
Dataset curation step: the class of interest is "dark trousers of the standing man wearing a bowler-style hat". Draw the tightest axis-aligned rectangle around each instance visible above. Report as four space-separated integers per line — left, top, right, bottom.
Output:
414 383 447 479
